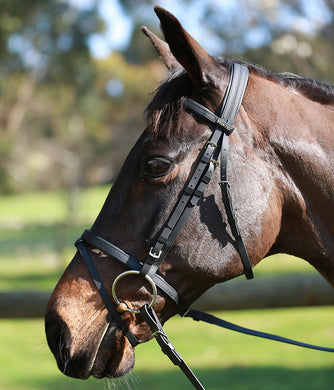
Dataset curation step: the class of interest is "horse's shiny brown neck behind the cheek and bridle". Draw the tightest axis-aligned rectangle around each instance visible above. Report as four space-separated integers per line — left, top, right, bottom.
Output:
246 78 334 285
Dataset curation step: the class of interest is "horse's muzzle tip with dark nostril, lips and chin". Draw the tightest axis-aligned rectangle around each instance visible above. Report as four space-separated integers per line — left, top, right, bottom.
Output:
45 311 135 379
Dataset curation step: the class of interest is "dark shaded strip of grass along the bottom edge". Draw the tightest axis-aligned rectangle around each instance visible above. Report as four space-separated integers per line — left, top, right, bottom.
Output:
8 367 334 390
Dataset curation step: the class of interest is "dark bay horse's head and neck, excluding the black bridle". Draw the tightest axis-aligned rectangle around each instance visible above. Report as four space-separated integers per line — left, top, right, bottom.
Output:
45 7 334 379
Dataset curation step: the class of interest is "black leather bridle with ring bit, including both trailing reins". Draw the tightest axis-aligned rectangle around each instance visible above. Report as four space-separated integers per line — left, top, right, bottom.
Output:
75 63 334 389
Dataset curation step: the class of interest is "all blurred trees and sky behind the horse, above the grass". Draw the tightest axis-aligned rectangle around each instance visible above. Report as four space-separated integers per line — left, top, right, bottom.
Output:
0 0 334 193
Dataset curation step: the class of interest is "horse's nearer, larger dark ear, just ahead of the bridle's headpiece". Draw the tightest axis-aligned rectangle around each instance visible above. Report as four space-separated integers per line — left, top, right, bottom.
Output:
154 5 222 88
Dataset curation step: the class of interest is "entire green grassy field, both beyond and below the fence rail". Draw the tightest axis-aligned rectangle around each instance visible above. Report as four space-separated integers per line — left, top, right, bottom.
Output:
0 187 334 390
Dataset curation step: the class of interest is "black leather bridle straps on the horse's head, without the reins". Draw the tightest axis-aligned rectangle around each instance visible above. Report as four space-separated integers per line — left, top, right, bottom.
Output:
75 64 253 343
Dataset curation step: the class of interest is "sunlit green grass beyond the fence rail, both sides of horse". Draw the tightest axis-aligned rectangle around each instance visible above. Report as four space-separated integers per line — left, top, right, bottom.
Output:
0 186 314 290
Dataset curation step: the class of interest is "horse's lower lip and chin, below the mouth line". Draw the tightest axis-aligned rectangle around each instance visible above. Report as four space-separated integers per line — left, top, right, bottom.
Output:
91 324 135 379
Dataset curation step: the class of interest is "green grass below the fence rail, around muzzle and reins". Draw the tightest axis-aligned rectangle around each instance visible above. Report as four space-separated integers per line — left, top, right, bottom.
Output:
0 307 334 390
